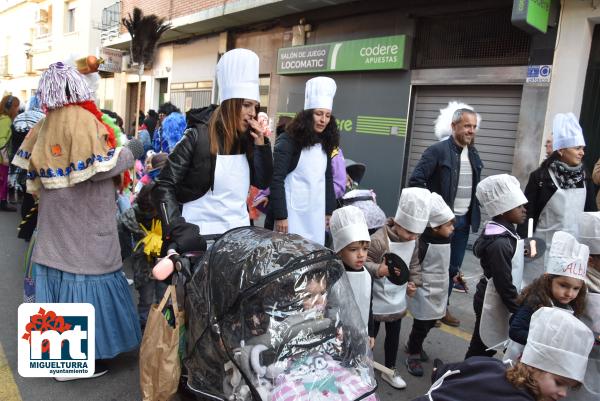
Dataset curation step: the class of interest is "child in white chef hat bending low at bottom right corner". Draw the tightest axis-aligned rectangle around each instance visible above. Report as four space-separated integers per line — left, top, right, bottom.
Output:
414 307 594 401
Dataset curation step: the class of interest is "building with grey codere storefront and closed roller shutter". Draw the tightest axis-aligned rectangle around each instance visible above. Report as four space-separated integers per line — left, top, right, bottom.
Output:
92 0 600 214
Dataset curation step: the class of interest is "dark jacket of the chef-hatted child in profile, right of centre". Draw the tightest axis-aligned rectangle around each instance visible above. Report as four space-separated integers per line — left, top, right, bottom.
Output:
473 218 519 313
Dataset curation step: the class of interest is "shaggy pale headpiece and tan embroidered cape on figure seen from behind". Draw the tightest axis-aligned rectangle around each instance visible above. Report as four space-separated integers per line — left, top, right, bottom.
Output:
13 62 121 193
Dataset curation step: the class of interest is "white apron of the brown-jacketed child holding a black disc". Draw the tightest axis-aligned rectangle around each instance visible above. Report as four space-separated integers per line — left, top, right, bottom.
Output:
373 238 416 315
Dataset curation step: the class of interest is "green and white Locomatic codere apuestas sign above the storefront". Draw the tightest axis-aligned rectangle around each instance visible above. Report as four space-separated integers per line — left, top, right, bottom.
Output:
277 35 408 75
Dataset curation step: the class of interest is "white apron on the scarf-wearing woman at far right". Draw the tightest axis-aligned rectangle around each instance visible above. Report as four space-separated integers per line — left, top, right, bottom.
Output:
522 170 587 288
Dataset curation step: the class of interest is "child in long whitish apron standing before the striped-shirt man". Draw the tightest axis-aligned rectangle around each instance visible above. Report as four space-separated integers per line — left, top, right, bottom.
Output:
406 192 454 376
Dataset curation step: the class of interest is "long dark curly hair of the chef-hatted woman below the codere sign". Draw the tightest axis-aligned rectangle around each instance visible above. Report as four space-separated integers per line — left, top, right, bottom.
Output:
285 109 340 156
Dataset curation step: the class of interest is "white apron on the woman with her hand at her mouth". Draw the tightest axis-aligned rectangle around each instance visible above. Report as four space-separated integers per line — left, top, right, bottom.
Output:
181 154 250 235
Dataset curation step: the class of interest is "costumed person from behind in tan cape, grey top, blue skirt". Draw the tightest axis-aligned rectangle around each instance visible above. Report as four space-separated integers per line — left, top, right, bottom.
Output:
13 63 141 359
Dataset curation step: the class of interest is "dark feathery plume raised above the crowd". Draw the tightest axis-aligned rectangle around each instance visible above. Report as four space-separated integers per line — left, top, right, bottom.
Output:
122 7 171 68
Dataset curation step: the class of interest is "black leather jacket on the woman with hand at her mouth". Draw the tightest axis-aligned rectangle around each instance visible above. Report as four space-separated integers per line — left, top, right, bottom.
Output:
152 105 273 239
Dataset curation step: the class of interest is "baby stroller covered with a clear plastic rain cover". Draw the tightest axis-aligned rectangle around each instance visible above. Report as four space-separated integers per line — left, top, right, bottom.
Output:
183 227 377 401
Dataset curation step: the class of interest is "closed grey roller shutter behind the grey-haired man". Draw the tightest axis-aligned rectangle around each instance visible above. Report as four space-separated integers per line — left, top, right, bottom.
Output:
405 86 522 238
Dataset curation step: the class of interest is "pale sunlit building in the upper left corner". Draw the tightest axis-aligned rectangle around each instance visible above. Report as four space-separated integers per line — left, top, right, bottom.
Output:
0 0 111 102
